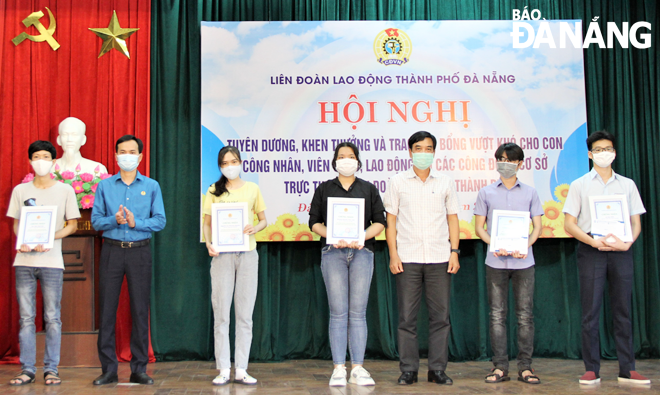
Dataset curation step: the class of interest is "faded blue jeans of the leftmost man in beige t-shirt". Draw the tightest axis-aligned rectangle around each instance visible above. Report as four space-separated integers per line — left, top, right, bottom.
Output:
15 266 64 373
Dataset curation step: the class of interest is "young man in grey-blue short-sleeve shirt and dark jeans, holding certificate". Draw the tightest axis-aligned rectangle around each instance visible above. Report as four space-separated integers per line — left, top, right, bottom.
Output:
474 143 543 384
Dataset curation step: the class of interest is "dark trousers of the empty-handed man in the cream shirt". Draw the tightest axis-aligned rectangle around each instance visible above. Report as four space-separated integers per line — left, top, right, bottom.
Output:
395 262 451 372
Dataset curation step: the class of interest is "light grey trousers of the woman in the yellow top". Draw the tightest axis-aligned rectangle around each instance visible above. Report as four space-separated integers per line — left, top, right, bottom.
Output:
211 250 259 369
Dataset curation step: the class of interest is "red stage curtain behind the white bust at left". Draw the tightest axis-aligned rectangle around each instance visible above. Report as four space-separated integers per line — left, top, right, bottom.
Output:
0 0 155 362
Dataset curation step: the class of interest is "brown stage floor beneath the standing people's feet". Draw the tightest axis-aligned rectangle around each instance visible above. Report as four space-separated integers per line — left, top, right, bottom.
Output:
0 359 660 395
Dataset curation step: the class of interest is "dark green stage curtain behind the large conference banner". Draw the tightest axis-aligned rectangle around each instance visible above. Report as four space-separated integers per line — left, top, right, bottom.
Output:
151 0 660 361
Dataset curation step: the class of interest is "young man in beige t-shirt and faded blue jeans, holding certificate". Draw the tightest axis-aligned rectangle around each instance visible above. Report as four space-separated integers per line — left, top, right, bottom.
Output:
7 140 80 386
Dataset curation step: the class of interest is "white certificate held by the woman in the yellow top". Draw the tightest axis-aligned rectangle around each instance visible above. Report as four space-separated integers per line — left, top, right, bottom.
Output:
211 202 250 252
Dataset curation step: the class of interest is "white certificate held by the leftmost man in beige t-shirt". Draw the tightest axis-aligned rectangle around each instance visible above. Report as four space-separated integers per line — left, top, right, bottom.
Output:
16 206 57 250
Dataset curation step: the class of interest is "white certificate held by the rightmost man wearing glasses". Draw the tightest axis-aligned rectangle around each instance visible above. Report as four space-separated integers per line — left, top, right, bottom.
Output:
589 195 633 242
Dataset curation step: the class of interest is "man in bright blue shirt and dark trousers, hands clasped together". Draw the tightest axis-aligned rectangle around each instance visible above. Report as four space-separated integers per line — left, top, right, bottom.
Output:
92 135 166 385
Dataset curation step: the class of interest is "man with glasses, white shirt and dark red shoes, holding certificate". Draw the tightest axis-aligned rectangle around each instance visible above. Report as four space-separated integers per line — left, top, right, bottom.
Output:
563 131 651 384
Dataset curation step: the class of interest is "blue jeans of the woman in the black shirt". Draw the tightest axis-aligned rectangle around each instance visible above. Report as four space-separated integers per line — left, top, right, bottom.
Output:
321 246 374 365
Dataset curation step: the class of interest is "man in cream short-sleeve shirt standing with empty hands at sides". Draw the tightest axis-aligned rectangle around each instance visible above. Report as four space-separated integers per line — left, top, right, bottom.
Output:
384 132 460 385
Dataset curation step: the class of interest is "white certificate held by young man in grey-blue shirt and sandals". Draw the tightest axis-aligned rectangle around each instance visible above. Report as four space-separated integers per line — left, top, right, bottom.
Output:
489 210 529 255
